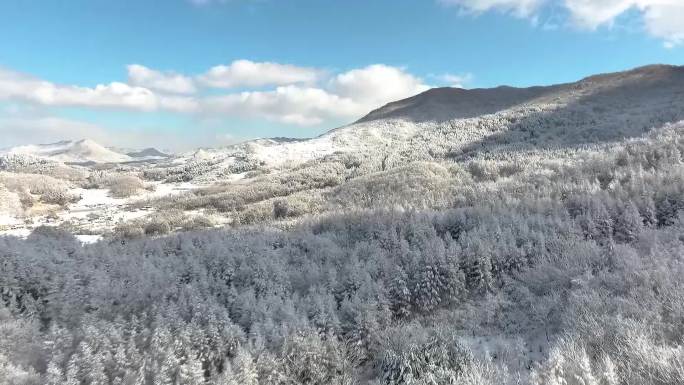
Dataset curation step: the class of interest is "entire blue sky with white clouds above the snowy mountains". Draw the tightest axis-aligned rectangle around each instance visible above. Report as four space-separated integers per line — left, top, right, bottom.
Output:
0 0 684 149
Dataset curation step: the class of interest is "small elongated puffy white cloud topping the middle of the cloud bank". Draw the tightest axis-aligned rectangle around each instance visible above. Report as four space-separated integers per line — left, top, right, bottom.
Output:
199 60 323 88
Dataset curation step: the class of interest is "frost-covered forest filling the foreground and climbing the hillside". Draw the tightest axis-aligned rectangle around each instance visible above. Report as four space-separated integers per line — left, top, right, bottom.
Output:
0 64 684 385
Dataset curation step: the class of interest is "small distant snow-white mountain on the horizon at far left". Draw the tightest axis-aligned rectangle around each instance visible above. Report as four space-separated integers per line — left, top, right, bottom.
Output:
4 139 132 163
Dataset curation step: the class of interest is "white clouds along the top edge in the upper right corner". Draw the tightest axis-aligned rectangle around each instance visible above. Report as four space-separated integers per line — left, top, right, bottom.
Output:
438 0 684 47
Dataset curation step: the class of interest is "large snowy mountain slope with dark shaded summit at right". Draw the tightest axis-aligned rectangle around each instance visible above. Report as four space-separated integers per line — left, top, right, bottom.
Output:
178 65 684 176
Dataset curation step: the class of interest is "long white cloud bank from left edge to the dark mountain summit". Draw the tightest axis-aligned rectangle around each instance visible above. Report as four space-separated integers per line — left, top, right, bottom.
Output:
0 60 432 134
